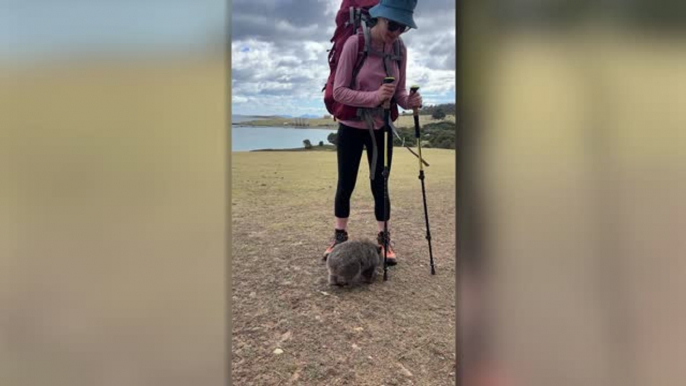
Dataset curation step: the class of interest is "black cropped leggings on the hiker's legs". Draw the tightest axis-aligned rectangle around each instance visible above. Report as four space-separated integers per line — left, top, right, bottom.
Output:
334 124 393 221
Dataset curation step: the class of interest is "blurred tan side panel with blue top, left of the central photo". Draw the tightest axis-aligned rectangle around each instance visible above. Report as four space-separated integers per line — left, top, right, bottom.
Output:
0 1 228 386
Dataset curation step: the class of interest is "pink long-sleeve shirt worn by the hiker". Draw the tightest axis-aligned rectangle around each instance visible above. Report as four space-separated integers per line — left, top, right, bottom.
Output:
333 35 409 130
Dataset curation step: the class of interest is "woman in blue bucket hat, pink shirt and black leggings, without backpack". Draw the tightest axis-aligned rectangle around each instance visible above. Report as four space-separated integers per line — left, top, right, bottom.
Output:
324 0 422 265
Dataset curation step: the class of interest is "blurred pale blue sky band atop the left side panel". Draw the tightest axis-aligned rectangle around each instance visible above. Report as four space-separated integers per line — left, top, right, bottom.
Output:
0 0 224 61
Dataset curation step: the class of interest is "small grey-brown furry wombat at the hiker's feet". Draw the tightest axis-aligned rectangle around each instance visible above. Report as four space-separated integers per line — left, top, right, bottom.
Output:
326 240 383 286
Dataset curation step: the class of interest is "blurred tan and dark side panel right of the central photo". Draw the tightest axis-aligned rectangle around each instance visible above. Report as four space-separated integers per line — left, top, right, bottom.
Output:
460 0 686 386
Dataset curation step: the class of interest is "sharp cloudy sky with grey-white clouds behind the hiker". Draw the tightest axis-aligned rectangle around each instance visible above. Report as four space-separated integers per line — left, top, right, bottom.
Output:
230 0 455 116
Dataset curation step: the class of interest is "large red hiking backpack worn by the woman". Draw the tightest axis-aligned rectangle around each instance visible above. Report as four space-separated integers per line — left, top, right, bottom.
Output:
322 0 403 121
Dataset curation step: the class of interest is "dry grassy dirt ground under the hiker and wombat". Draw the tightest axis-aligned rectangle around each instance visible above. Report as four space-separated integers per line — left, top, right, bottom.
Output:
231 149 455 386
